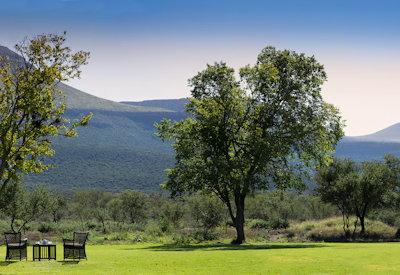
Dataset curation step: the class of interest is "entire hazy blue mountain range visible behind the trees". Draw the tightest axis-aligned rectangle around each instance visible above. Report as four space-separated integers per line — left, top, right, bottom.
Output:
0 46 400 192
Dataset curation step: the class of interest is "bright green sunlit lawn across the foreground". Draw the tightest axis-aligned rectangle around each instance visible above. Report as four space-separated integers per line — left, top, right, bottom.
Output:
0 243 400 274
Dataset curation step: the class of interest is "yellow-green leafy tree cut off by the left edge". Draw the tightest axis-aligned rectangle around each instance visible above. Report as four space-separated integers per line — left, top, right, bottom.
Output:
0 33 91 196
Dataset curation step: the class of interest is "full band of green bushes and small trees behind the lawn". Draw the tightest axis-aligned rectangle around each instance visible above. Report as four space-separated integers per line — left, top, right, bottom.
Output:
0 155 400 245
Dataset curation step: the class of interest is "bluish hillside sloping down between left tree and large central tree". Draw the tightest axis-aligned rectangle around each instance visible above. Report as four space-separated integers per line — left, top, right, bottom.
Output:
26 96 183 191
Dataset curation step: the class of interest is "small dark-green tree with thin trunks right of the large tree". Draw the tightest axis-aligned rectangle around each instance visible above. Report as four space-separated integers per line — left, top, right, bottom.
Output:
316 159 398 237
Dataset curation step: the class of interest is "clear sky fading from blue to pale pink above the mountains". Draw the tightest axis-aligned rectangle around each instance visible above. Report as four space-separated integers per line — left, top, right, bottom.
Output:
0 0 400 135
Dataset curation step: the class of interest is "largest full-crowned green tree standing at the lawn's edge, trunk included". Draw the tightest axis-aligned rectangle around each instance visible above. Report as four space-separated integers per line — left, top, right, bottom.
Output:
157 47 343 244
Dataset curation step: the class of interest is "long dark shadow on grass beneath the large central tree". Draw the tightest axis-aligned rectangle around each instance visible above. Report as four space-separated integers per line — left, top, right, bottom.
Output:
136 243 325 251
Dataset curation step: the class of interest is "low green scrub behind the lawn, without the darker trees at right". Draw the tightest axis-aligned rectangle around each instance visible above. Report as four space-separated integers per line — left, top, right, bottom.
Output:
0 184 400 242
